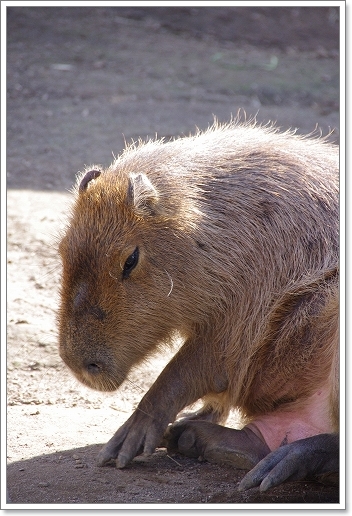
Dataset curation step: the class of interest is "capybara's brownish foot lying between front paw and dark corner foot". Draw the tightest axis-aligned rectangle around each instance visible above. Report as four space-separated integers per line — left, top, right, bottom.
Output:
164 421 270 470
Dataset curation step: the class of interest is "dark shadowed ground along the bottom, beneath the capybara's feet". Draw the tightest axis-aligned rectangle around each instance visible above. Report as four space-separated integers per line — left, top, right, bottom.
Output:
8 445 339 504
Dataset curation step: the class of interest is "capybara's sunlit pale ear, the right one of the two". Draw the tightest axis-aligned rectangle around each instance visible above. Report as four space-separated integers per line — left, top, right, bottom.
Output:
127 174 159 215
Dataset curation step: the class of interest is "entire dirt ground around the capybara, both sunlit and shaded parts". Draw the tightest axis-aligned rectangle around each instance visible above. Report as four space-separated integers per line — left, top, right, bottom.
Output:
2 2 343 509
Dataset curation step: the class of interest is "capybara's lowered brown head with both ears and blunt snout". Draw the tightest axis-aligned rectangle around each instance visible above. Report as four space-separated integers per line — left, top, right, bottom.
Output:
59 141 206 390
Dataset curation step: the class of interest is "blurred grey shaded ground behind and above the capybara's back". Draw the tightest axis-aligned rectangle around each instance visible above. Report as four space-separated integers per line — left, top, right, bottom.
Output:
7 2 339 190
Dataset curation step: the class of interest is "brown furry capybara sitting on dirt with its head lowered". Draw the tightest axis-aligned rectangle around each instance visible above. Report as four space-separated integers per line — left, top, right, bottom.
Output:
58 121 339 490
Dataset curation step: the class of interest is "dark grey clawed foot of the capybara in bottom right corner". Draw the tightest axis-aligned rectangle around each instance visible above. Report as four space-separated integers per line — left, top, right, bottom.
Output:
239 434 339 491
